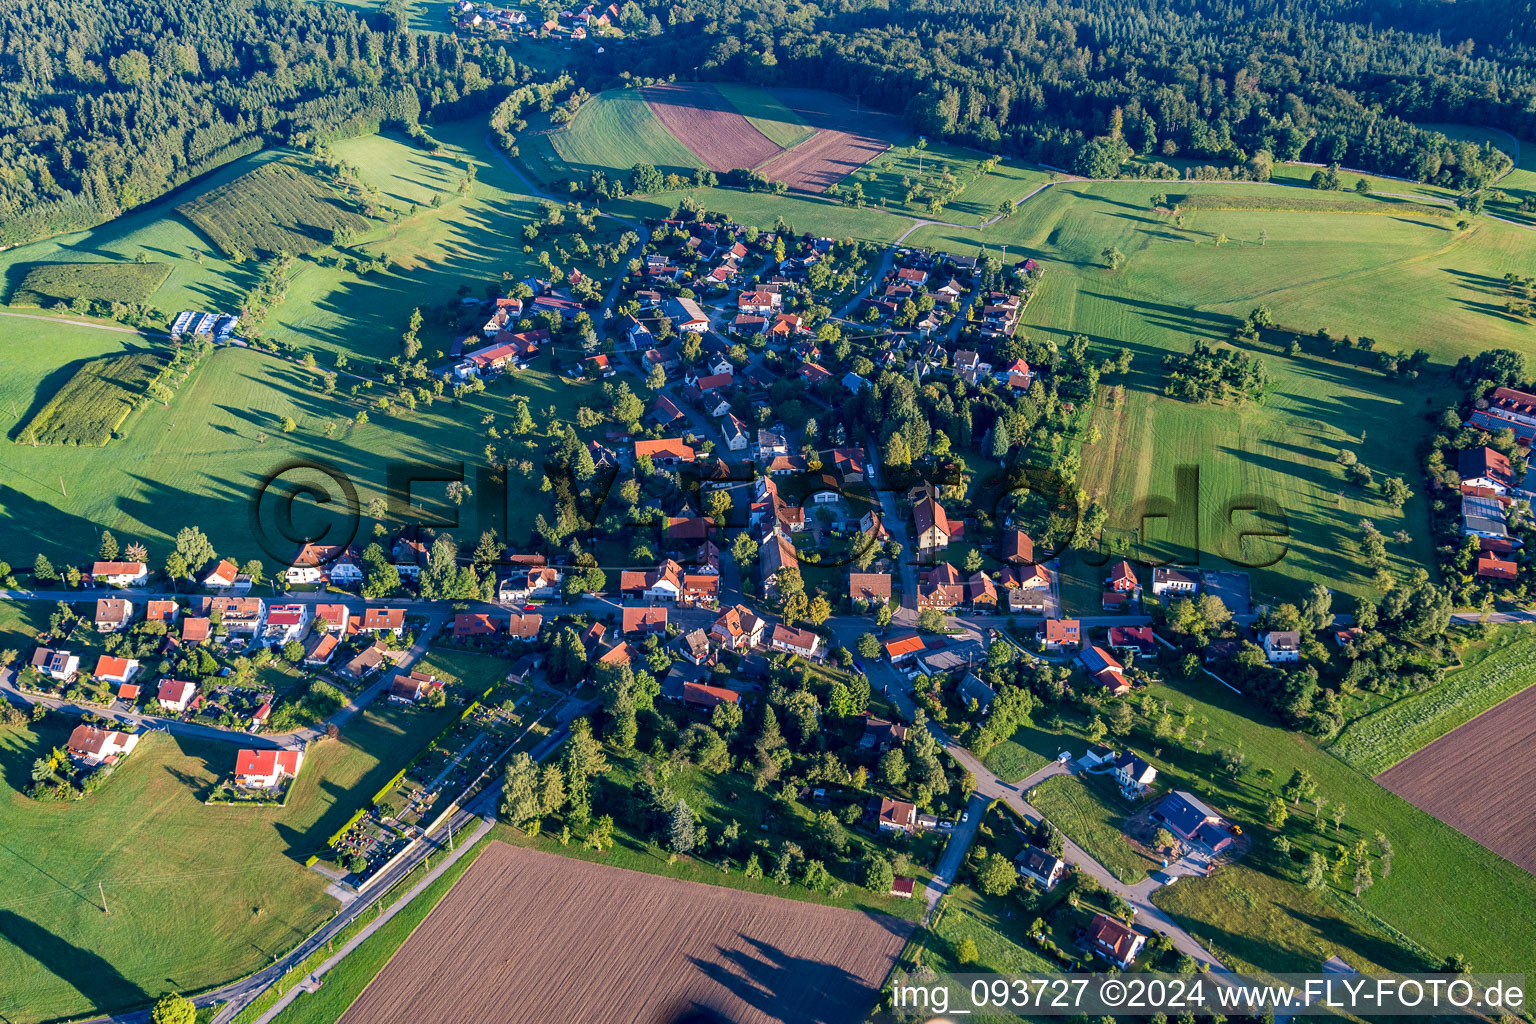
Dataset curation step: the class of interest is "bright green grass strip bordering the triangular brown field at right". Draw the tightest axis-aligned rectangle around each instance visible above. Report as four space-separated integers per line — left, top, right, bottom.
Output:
1329 626 1536 775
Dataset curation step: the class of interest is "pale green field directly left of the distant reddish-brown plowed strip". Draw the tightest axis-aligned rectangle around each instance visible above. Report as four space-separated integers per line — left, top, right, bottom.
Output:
518 89 700 184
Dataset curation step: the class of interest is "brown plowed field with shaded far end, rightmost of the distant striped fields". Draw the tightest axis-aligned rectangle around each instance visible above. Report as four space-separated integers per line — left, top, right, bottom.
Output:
759 89 908 193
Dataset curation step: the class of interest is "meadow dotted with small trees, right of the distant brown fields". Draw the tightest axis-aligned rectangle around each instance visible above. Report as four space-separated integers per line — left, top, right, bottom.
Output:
842 143 1051 224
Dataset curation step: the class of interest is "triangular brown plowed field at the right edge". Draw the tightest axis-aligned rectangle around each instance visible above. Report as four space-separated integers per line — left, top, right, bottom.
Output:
1376 686 1536 874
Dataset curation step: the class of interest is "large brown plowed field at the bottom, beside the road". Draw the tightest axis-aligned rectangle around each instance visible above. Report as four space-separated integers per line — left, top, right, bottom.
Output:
339 843 914 1024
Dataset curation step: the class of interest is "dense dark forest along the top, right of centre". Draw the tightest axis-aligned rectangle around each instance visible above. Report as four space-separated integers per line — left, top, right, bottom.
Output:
599 0 1536 187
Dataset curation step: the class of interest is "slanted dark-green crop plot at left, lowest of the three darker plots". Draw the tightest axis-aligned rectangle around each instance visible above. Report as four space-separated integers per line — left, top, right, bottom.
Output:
15 348 167 447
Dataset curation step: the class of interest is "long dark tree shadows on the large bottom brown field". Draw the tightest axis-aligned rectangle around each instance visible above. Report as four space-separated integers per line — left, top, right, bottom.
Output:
690 935 874 1024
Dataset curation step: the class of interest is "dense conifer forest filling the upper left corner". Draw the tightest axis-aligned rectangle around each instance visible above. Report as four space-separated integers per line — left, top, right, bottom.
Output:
0 0 527 246
